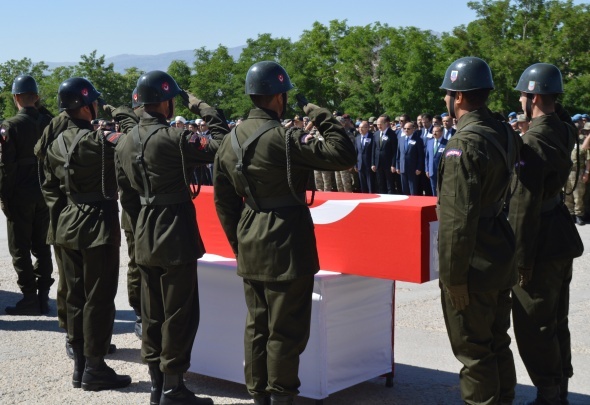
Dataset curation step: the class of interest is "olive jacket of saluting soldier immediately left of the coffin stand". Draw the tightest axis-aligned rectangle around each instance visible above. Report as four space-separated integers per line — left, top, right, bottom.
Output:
116 103 229 267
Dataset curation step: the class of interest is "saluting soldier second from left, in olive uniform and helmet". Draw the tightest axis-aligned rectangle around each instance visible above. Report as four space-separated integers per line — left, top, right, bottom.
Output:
43 77 137 391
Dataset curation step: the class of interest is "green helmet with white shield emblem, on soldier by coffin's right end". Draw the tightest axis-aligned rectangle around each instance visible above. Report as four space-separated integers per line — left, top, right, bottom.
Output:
440 56 494 91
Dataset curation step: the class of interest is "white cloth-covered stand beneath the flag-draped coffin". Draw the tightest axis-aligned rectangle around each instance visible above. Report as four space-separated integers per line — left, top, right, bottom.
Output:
190 255 395 400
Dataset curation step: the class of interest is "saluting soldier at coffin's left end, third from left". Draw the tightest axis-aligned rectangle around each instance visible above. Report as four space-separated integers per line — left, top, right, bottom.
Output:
116 70 229 405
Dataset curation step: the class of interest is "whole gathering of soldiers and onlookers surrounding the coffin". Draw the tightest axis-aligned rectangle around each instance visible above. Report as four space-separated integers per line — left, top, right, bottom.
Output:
0 57 590 405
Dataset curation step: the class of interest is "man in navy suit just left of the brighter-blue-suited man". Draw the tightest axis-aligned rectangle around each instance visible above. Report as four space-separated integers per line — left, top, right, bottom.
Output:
395 122 424 195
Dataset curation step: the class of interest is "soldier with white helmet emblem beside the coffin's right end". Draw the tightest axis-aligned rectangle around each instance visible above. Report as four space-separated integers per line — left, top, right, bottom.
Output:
437 57 522 404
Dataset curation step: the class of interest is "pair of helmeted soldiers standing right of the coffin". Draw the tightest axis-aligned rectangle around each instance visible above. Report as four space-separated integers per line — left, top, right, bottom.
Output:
437 57 583 405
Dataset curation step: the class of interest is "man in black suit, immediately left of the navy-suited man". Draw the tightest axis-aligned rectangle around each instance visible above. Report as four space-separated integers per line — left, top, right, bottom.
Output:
371 114 401 194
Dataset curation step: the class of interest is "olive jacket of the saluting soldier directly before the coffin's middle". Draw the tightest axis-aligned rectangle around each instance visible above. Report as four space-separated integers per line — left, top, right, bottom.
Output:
213 108 356 281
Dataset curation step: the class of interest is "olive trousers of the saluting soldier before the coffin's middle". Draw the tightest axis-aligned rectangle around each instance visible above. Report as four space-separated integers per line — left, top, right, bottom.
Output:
244 275 314 398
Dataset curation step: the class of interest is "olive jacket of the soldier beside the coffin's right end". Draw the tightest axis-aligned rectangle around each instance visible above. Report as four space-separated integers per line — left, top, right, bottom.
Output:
438 108 522 292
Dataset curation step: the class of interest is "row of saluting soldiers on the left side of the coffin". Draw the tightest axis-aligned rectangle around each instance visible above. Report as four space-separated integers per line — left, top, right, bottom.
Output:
0 62 355 405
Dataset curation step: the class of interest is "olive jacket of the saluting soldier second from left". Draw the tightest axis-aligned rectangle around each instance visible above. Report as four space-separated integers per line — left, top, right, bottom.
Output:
43 108 137 250
